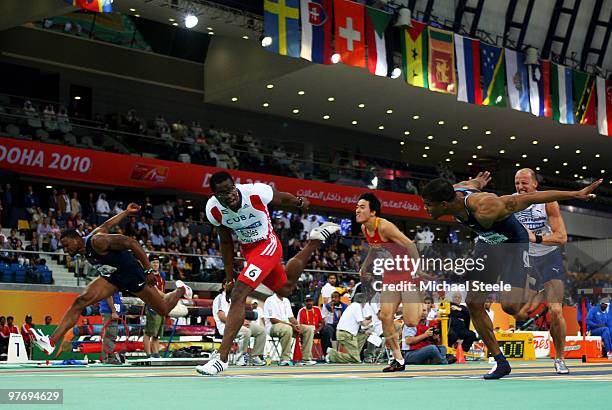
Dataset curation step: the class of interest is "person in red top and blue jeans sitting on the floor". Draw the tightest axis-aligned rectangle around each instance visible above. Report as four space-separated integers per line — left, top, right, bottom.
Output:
402 307 454 364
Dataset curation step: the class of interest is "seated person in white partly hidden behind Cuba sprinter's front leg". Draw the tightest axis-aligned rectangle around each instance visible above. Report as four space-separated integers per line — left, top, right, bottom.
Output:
212 281 266 366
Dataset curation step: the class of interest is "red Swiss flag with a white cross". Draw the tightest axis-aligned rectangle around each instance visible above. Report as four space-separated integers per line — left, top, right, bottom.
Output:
334 0 365 67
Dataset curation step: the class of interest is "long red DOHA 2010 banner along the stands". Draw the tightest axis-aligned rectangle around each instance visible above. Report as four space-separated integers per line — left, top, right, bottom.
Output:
0 137 436 219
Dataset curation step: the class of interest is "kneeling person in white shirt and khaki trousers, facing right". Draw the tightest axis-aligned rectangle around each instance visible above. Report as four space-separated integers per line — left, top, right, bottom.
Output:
325 293 372 363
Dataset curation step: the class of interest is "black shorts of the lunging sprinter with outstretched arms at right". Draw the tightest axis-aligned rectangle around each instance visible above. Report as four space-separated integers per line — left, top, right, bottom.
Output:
466 241 529 288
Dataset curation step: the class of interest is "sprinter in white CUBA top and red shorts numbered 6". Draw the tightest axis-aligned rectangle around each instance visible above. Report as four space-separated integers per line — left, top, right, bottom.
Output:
196 172 340 376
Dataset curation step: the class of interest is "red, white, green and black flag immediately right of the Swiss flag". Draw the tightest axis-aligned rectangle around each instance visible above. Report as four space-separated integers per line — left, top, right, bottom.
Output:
365 7 393 77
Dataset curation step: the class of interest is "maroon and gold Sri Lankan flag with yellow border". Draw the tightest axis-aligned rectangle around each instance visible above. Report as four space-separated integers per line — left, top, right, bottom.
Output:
428 27 457 94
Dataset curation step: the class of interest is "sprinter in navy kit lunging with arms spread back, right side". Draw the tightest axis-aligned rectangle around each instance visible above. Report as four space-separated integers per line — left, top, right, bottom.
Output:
421 172 602 379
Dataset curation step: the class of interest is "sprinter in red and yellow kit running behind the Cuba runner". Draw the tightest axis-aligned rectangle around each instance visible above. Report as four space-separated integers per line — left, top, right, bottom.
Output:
355 192 421 372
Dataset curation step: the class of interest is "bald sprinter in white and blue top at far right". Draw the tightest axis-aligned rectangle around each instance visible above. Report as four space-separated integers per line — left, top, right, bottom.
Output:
514 168 569 374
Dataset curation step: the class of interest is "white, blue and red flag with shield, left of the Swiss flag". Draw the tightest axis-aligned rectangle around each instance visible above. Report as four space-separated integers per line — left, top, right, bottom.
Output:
300 0 332 64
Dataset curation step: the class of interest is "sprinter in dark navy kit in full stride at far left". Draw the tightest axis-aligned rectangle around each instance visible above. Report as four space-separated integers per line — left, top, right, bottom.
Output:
32 204 193 355
